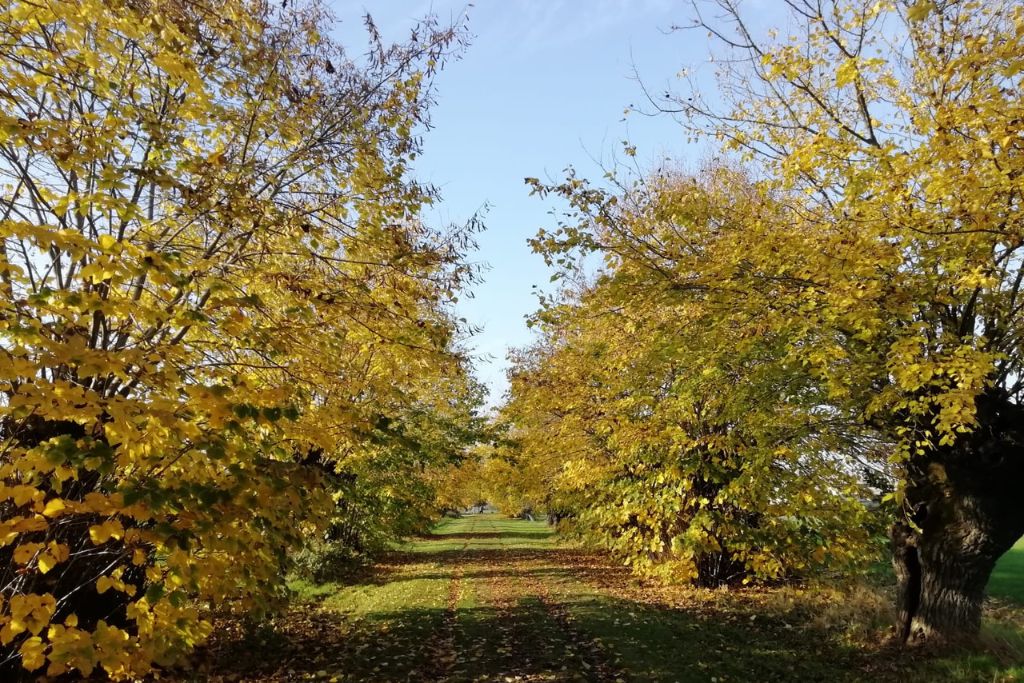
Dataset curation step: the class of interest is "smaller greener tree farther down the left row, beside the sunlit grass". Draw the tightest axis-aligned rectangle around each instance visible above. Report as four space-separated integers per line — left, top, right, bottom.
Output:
294 370 485 582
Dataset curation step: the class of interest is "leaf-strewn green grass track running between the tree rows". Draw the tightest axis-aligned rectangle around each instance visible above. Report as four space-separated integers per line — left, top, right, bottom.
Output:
197 515 1024 683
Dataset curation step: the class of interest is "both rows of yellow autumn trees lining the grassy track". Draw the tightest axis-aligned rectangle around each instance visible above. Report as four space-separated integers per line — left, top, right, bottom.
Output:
0 0 1024 680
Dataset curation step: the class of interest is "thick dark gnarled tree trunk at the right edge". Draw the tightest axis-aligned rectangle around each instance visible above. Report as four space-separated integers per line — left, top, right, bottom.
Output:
892 391 1024 642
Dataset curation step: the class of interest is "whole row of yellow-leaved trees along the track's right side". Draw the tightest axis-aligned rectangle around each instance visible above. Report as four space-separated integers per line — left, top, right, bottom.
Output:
503 0 1024 639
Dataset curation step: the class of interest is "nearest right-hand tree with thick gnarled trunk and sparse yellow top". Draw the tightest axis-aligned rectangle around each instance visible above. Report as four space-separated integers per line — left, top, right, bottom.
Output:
536 0 1024 640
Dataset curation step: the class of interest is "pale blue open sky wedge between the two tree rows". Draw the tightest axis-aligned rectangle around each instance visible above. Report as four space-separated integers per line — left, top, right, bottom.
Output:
333 0 733 403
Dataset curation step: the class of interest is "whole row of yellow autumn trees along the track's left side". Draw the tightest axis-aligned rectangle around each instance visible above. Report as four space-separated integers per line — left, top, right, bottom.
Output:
0 0 479 678
